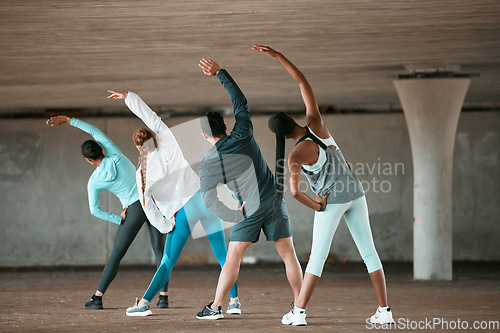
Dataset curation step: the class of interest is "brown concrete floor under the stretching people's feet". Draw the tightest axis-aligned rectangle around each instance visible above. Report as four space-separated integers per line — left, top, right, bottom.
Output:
0 264 500 332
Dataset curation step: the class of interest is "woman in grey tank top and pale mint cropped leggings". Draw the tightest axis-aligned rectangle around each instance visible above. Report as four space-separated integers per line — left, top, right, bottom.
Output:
253 46 394 325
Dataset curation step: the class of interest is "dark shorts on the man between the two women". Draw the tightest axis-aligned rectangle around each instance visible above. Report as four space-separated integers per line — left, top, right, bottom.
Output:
229 195 292 243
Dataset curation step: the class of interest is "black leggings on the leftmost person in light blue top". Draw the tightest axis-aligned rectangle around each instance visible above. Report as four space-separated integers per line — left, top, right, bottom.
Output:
97 200 168 294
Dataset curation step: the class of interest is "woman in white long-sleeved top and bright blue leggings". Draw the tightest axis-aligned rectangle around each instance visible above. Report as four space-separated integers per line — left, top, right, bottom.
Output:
108 90 241 316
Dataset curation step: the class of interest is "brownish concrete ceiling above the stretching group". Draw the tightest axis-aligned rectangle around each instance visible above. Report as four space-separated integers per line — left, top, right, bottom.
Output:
0 0 500 114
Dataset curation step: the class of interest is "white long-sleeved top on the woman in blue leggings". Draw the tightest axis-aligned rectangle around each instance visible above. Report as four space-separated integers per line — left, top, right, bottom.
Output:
125 91 200 233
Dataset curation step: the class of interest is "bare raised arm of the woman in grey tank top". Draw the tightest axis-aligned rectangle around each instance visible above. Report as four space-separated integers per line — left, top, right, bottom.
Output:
252 45 322 124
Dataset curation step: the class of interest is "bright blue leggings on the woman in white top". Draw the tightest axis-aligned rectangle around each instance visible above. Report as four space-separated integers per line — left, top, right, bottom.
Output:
142 191 238 302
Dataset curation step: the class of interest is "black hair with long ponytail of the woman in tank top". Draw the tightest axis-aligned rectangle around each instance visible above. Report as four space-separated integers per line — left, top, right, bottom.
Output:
268 112 297 205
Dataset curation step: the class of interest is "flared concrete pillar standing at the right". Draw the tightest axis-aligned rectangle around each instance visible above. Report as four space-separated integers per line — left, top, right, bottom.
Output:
394 78 470 280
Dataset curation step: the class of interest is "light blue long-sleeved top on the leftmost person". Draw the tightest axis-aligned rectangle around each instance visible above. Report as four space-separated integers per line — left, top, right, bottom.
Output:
71 118 139 224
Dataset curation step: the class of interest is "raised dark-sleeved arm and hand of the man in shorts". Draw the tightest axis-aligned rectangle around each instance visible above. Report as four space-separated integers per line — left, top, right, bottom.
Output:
199 58 253 135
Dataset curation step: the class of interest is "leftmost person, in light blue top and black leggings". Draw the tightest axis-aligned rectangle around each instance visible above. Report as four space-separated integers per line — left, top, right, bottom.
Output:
47 116 168 309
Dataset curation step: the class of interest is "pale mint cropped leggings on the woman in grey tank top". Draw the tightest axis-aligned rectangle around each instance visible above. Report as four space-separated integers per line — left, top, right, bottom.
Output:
306 196 382 276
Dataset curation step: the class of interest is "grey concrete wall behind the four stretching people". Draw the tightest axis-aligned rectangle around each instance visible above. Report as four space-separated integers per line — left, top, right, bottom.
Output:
0 112 500 266
